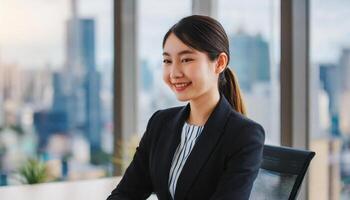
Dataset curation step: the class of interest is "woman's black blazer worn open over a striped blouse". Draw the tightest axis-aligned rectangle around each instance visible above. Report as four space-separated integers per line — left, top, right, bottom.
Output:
108 94 265 200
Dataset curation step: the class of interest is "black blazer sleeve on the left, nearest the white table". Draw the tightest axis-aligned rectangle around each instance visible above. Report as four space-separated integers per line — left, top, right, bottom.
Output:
107 111 159 200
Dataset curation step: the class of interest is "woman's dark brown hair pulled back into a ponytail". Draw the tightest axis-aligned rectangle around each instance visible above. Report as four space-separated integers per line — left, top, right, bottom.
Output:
163 15 246 115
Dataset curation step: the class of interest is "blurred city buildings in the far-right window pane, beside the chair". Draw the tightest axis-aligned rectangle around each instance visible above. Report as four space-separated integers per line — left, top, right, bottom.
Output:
309 47 350 199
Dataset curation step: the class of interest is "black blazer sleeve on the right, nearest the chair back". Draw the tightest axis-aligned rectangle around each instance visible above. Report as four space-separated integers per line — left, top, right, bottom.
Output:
211 124 265 200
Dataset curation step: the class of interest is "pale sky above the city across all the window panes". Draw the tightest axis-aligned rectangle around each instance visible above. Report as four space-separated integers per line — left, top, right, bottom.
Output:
0 0 350 68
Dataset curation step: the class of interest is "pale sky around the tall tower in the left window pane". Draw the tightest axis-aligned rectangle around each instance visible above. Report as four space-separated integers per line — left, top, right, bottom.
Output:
0 0 113 68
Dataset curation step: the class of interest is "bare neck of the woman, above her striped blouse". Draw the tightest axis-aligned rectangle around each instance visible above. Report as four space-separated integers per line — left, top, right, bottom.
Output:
187 91 220 126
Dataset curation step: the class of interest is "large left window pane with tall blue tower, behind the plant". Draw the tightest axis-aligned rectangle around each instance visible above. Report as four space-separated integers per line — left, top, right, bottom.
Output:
0 0 113 185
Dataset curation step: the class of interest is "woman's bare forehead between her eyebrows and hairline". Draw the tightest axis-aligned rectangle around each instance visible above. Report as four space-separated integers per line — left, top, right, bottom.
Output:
163 33 199 56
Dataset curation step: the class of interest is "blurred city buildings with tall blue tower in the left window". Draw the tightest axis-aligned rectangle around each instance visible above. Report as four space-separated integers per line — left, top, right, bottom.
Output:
0 0 113 185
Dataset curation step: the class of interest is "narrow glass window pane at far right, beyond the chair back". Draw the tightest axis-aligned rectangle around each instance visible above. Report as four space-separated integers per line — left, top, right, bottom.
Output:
309 0 350 199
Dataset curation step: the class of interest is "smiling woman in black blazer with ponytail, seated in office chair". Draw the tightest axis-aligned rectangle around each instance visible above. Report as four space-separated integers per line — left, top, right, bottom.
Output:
108 15 265 200
